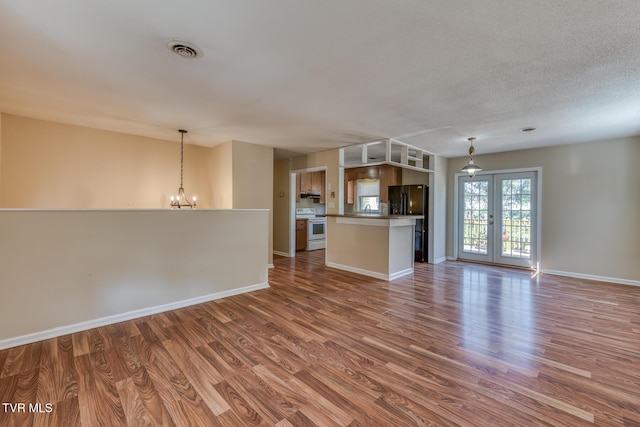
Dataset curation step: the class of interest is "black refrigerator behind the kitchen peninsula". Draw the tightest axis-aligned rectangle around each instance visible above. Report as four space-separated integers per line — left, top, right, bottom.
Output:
389 185 429 262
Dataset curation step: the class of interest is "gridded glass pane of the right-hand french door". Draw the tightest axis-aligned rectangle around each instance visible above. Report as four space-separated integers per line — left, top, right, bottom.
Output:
501 178 532 259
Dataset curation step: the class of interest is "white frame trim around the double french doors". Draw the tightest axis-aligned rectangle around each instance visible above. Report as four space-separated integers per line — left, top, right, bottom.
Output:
453 167 542 271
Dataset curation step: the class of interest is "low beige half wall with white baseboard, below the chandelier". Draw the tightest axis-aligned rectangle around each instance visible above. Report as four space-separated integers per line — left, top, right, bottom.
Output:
0 209 269 349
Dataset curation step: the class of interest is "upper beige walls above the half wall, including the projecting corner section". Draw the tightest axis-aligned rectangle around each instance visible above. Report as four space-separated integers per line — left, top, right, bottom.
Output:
0 114 273 260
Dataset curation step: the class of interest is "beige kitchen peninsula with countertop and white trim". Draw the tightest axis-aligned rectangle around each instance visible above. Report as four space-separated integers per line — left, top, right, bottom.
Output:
326 214 424 280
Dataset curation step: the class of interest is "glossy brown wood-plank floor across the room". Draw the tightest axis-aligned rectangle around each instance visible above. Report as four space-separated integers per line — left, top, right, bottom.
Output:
0 251 640 427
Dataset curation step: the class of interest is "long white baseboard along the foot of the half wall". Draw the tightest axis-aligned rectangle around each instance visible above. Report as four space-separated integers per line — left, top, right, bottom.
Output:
0 283 269 350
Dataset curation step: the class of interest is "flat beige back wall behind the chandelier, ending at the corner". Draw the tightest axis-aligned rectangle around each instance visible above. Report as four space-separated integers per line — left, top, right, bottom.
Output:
0 114 211 208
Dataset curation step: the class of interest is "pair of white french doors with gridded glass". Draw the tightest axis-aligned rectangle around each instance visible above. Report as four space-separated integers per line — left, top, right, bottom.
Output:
458 171 538 267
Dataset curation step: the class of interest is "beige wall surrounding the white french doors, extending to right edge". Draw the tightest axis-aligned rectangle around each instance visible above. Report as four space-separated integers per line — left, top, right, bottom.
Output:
447 137 640 281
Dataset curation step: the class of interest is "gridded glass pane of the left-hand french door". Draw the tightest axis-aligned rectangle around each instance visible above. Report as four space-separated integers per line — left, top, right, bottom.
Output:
463 181 489 254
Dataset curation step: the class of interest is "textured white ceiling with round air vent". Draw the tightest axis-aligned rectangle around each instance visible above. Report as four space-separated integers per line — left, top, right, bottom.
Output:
0 0 640 156
